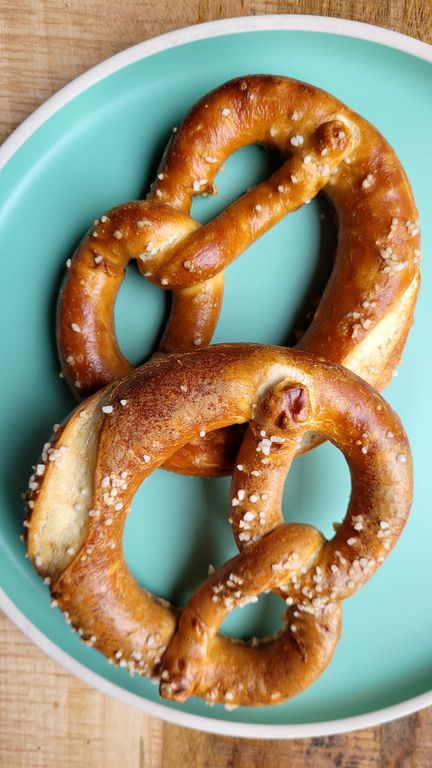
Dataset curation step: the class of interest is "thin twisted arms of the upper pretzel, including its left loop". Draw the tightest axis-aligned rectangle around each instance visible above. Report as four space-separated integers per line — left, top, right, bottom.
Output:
58 113 350 396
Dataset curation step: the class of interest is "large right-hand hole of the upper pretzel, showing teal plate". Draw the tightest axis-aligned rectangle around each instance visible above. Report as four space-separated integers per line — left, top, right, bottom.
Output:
213 195 337 346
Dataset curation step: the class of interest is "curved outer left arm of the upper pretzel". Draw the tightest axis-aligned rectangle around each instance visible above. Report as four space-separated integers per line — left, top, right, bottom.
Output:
57 201 199 397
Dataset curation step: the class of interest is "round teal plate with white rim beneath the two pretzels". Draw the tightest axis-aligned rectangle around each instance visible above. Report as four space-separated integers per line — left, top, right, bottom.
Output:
0 16 432 738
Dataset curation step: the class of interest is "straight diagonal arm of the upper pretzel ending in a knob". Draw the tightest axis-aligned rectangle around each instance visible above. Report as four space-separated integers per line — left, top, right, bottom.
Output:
139 120 353 289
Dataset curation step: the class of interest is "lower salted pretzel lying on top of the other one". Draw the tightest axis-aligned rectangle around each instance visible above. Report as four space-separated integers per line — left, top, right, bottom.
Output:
27 344 412 706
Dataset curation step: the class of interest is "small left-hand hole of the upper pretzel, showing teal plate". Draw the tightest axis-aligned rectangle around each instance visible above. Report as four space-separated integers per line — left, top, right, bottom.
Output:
114 262 170 365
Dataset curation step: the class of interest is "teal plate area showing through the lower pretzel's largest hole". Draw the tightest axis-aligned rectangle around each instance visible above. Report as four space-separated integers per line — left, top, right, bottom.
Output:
123 470 233 605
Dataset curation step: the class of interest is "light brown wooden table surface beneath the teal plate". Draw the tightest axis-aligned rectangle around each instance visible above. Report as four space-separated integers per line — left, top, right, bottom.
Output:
0 0 432 768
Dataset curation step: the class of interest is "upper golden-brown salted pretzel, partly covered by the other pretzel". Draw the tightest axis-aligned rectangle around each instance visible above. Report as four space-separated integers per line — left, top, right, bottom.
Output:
57 75 420 475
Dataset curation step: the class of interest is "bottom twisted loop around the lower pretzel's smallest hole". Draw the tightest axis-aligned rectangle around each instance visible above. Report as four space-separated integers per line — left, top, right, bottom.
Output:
160 525 341 705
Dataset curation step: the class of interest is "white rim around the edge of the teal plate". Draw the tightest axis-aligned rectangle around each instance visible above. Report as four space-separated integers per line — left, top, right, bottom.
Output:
0 14 432 739
